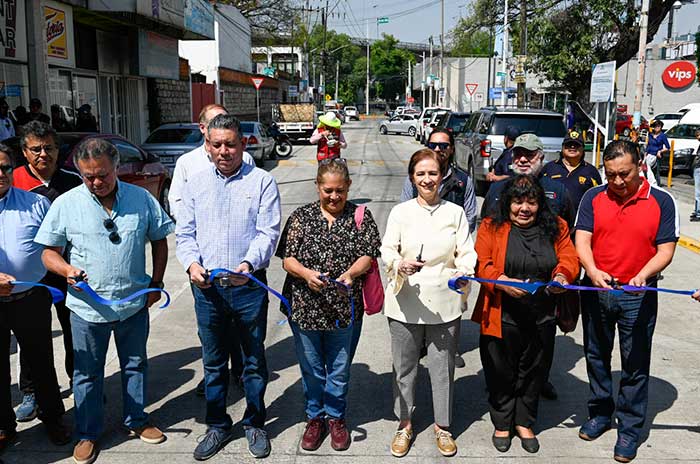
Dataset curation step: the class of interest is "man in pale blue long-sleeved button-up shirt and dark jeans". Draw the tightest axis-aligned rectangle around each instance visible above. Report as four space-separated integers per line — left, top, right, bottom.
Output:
176 114 281 461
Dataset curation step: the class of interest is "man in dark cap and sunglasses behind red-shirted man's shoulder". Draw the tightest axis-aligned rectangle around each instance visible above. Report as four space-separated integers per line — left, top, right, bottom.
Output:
542 131 603 211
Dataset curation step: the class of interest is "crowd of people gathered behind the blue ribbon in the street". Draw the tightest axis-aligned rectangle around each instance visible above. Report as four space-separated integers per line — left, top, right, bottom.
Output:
0 105 688 464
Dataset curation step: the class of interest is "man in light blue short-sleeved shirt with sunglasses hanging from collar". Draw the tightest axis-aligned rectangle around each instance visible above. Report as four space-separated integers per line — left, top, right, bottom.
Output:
35 137 174 462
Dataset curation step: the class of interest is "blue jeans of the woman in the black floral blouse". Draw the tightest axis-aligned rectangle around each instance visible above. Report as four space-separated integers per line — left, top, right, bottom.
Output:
291 322 359 419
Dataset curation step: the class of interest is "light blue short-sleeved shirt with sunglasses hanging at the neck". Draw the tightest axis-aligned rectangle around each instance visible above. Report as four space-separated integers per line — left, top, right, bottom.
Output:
35 181 174 322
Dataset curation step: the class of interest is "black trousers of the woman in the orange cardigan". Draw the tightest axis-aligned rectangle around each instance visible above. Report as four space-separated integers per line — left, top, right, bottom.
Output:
479 321 556 430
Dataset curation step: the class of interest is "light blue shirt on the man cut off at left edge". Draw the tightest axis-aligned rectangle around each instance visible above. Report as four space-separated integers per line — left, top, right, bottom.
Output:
0 187 50 293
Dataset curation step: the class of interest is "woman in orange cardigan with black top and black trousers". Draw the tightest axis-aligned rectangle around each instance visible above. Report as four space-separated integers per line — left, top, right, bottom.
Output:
472 175 579 453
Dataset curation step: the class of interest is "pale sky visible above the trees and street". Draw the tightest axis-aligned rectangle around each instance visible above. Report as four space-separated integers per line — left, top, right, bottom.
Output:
318 0 700 51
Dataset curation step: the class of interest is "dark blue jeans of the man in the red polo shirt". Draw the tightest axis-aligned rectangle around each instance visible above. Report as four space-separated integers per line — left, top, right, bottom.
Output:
581 281 658 446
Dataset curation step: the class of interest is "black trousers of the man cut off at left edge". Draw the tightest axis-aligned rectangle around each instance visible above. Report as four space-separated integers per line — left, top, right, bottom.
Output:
0 289 65 430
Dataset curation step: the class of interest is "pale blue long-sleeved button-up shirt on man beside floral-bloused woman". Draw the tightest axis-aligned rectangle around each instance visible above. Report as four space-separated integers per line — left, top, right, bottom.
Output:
175 163 281 270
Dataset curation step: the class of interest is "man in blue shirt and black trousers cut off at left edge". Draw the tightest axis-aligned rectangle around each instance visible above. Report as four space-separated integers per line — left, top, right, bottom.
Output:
0 144 71 450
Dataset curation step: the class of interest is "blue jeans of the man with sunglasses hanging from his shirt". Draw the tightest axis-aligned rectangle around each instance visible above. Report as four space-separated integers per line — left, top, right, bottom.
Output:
70 308 150 440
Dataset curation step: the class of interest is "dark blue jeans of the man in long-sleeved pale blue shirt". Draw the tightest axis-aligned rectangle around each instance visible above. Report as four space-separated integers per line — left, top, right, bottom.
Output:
192 275 268 430
